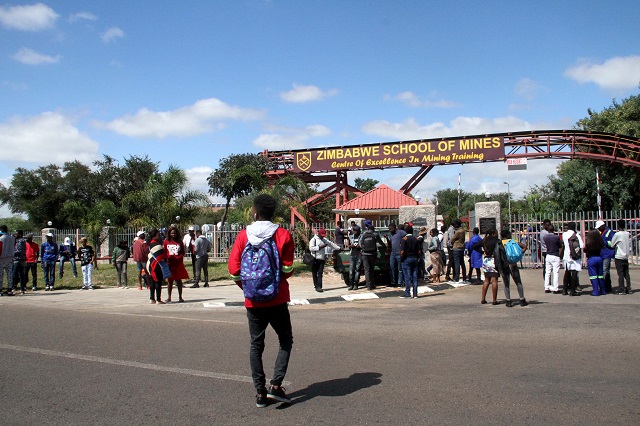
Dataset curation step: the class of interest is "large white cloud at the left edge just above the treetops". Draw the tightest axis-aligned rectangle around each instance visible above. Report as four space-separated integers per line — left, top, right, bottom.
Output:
0 112 98 164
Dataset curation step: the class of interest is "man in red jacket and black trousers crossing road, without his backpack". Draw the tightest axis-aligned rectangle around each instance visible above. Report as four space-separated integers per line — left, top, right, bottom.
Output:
228 194 294 408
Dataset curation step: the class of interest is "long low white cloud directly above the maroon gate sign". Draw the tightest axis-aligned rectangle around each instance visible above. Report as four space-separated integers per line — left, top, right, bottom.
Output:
362 117 532 140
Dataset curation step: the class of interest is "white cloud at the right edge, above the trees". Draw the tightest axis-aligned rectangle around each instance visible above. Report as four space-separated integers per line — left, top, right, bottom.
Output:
564 56 640 91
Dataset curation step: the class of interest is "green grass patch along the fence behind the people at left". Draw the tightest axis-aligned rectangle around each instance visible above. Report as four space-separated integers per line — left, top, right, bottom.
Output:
47 262 311 290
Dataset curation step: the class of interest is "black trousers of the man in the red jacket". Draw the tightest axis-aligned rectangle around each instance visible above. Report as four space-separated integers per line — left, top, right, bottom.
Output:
247 303 293 392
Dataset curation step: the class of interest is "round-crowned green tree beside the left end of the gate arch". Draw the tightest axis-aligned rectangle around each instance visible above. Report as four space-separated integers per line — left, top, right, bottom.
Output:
207 154 269 230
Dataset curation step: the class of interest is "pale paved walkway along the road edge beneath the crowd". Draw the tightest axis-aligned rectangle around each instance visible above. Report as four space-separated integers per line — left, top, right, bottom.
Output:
0 269 640 310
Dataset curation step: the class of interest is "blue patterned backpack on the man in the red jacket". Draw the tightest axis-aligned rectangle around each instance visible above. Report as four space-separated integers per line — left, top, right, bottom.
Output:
240 236 280 302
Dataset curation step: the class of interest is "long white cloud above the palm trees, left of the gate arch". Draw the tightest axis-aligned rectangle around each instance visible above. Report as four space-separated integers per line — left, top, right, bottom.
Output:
96 98 264 139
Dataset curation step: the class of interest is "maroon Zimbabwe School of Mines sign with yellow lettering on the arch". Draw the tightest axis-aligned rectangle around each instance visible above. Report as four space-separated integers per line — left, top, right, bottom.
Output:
292 136 505 172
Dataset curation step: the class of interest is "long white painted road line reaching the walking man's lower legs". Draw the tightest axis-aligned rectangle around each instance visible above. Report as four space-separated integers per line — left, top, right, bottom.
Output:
0 343 291 385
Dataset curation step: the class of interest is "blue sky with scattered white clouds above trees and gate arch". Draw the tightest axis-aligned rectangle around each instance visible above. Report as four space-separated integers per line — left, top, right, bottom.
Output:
0 0 640 216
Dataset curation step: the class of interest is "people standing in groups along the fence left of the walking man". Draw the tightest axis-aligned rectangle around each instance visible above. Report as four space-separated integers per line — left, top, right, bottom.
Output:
0 225 211 304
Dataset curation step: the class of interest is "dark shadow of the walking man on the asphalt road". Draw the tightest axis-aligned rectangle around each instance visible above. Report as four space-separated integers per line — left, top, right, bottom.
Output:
282 373 382 408
